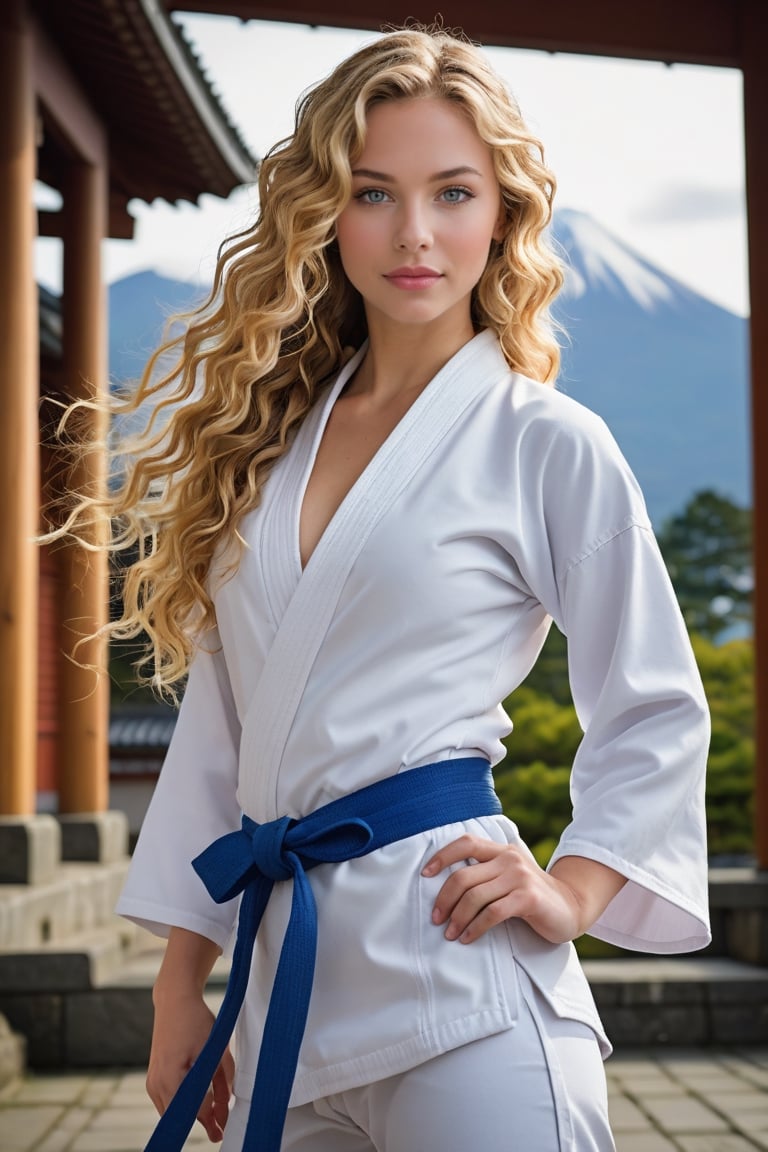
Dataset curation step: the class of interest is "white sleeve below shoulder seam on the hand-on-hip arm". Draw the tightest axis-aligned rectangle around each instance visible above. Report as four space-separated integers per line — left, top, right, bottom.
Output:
550 525 710 953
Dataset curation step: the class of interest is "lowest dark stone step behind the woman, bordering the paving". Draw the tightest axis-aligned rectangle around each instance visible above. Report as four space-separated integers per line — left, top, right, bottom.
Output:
6 931 768 1068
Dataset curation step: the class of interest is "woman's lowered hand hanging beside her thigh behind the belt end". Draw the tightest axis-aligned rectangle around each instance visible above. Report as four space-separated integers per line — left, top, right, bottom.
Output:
146 993 235 1142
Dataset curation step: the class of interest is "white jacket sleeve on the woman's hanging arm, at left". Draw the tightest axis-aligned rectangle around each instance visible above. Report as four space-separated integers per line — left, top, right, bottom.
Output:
116 629 241 948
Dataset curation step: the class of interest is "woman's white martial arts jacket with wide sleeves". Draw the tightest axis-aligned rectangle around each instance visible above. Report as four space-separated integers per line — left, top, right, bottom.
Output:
119 332 709 1142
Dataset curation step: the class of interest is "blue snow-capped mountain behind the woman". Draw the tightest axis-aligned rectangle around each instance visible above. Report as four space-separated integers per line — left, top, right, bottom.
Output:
109 210 751 524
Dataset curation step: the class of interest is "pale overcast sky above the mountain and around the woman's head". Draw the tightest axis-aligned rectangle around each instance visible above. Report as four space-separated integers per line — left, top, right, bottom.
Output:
33 16 748 314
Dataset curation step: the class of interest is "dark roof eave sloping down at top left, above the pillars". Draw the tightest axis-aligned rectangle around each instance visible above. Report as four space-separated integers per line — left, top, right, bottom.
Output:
31 0 258 203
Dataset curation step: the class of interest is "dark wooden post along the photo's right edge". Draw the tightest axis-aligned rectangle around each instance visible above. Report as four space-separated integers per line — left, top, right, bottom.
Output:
742 0 768 870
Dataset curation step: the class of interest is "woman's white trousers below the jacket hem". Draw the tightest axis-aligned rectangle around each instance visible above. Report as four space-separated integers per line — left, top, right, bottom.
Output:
221 972 615 1152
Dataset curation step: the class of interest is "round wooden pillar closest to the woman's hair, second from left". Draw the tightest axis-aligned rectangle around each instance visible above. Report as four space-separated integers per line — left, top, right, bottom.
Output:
59 162 109 813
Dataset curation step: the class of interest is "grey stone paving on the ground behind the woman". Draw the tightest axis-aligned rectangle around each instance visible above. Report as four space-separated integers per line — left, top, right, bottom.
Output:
0 1048 768 1152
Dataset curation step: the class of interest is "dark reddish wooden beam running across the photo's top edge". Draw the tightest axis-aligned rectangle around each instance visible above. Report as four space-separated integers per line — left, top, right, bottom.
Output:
167 0 742 67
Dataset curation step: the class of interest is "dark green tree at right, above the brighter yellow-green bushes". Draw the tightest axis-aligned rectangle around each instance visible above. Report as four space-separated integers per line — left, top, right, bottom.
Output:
659 491 752 639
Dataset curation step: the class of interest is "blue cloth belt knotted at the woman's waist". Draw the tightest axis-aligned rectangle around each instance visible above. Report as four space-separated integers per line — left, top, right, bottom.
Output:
145 757 502 1152
